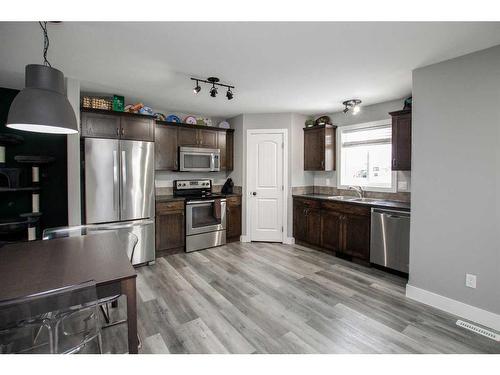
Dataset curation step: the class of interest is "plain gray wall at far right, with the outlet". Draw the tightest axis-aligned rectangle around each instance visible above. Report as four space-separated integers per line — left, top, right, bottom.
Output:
409 46 500 314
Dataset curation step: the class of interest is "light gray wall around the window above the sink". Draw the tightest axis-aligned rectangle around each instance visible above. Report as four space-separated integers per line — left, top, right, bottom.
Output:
314 98 411 192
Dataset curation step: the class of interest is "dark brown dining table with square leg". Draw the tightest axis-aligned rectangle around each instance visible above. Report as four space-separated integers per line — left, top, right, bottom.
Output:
0 231 139 354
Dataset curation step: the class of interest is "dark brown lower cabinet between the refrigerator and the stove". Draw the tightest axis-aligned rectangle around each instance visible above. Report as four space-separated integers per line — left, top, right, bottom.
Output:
156 201 185 257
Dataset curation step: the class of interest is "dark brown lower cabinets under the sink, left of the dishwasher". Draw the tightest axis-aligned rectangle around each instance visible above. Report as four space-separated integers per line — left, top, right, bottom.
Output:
293 198 370 262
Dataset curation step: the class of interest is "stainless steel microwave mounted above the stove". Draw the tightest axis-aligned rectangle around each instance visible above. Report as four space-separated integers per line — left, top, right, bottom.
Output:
179 147 220 172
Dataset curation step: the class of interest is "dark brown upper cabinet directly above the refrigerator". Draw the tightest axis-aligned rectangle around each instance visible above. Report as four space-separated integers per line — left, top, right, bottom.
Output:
81 110 154 142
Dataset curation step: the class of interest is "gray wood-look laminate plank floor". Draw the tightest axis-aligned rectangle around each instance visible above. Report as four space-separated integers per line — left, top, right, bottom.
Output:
100 243 500 353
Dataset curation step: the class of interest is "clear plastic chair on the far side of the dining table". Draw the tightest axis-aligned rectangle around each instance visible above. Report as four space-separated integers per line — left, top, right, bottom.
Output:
42 225 141 346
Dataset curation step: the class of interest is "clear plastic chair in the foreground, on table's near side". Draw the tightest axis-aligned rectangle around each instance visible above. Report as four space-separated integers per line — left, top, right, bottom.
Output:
0 281 102 353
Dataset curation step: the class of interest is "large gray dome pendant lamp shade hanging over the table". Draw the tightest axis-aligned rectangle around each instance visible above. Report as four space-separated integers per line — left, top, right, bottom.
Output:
7 64 78 134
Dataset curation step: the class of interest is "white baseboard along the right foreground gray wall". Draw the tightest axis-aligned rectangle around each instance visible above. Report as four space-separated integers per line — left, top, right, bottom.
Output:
406 284 500 331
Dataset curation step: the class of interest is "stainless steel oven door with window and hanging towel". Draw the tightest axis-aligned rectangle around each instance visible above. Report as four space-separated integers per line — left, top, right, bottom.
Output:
186 199 226 236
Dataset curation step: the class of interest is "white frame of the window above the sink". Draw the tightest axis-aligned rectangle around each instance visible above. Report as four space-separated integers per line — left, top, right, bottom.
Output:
335 118 398 193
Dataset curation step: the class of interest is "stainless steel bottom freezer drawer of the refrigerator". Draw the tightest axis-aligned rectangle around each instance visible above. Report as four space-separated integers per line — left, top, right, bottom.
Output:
94 219 155 266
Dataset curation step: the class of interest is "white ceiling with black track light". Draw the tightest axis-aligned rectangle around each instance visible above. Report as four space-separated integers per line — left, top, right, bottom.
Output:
0 22 500 117
